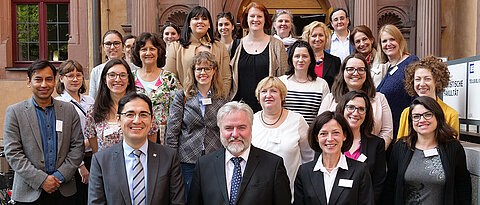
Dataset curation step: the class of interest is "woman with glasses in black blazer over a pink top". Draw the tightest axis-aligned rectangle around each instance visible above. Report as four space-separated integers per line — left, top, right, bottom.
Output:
336 90 387 204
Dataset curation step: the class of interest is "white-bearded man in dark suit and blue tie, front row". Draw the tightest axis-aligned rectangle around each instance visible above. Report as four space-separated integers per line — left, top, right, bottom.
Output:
188 101 292 205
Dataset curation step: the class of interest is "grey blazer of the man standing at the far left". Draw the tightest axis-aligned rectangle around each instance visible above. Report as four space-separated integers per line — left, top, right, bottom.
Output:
3 98 85 202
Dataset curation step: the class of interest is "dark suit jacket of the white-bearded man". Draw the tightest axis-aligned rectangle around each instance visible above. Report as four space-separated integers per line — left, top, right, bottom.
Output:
188 146 292 205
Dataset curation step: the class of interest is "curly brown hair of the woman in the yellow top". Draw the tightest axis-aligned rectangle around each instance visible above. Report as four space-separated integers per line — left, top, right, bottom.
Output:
405 56 450 96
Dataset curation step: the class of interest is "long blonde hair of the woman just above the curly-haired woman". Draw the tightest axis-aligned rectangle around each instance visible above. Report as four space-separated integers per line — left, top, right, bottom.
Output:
375 24 410 63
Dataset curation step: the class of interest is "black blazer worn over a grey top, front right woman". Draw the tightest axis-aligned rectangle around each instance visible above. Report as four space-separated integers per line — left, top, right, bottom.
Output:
380 140 472 205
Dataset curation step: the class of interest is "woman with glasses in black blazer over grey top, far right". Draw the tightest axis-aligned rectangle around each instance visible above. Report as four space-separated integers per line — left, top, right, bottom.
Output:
381 96 472 205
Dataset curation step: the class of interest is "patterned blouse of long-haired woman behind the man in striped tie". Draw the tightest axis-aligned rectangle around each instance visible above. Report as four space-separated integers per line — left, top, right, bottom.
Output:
83 108 159 151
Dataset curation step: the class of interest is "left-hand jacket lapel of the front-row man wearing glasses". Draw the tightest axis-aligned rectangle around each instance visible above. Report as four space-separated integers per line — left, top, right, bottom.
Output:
112 143 132 205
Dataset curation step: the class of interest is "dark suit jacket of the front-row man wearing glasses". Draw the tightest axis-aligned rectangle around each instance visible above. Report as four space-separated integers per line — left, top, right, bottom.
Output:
88 141 185 205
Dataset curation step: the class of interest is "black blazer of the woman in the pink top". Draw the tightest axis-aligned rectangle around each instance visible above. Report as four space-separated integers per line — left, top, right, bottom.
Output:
360 136 387 204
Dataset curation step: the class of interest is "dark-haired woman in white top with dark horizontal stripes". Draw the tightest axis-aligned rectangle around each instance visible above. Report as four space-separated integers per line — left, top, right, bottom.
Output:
280 41 330 124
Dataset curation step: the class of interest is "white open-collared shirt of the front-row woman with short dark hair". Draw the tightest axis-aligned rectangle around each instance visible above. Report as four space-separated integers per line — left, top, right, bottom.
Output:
313 154 348 204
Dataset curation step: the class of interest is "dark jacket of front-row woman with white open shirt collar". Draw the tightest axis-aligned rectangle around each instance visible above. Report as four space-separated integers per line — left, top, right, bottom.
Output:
293 157 374 205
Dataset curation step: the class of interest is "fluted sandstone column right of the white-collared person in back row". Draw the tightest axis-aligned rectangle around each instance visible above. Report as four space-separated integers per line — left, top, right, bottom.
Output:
350 0 378 39
